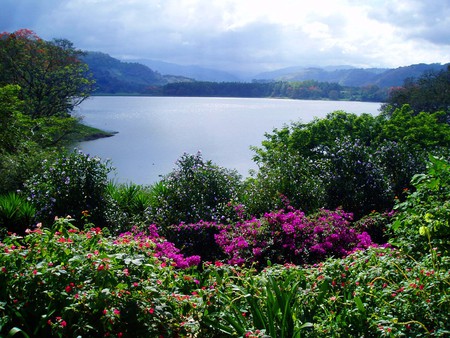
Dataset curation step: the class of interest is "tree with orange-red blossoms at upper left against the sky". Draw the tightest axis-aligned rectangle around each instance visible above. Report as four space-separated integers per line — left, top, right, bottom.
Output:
0 29 94 118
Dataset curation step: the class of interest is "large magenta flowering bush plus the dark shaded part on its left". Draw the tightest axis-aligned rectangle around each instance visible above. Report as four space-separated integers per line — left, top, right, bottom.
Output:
169 208 372 267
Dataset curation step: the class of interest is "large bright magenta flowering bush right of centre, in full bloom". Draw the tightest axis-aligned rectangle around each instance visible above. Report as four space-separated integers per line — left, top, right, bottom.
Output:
215 208 372 265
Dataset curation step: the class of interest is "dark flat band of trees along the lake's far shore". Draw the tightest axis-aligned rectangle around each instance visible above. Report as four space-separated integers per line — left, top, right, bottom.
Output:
144 80 388 102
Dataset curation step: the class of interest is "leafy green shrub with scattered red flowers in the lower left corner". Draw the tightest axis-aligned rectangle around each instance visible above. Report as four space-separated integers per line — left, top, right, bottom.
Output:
0 218 202 337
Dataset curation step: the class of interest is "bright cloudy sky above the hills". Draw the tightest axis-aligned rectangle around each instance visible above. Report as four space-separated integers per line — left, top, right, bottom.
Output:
0 0 450 74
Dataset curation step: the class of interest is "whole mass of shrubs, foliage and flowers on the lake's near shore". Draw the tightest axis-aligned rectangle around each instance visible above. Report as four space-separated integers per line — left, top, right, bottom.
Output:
0 33 450 337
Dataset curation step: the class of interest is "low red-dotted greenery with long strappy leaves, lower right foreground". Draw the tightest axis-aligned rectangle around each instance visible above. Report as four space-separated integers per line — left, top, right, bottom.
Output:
205 248 450 337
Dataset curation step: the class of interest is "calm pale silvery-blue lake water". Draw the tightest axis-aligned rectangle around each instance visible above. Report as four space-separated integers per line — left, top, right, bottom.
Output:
77 96 380 184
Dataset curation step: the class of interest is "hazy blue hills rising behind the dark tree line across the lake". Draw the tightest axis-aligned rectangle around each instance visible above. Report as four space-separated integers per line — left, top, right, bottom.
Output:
83 52 448 94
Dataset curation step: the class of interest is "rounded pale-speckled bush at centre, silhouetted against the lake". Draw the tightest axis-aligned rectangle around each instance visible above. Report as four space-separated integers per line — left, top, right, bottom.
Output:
150 153 240 230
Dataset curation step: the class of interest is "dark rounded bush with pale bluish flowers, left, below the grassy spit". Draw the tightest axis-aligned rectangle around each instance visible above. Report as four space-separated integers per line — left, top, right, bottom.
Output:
23 151 112 226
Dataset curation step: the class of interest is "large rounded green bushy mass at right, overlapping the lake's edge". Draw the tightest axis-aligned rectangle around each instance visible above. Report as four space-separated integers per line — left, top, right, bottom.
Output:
248 106 450 218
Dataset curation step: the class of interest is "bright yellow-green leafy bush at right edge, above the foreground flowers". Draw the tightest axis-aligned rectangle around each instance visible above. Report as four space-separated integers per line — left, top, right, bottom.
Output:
391 156 450 256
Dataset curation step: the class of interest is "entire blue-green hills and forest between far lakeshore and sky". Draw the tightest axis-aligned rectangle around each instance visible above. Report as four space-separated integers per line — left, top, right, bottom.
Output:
83 52 447 101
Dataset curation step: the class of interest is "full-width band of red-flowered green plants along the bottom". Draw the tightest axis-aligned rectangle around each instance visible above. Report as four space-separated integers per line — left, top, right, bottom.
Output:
0 215 450 337
